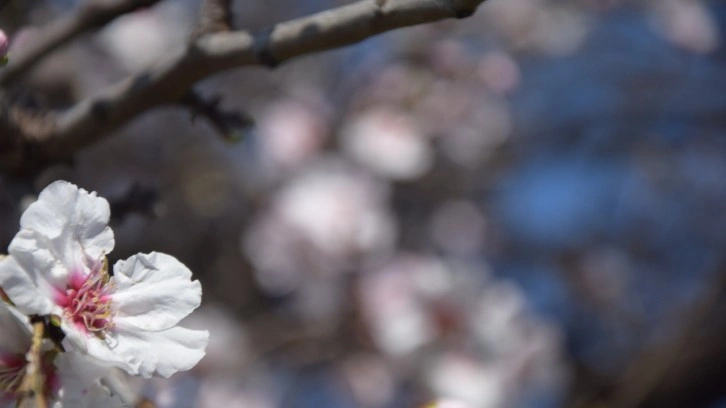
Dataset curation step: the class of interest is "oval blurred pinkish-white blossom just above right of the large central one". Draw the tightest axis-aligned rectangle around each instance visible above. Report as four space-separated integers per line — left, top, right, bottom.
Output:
341 107 433 180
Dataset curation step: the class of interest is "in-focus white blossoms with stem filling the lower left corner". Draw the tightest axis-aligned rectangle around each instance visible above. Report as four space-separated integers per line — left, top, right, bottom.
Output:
0 181 209 408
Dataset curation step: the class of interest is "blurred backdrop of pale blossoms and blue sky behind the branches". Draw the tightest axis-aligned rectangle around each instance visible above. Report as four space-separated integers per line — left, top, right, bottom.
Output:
0 0 726 408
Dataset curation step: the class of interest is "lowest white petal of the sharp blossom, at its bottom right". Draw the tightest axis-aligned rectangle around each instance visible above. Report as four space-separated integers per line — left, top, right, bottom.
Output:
107 327 209 378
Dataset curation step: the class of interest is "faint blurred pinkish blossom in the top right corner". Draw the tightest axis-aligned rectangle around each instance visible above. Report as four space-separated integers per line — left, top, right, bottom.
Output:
653 0 720 54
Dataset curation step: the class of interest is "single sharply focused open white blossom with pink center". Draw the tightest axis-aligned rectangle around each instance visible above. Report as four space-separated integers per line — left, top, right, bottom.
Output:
0 181 209 377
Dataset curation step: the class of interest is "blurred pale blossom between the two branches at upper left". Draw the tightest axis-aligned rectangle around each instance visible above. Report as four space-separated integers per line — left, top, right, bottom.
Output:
102 2 193 72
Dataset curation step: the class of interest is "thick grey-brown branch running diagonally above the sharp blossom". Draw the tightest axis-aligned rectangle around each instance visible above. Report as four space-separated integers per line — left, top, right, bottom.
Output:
0 0 484 172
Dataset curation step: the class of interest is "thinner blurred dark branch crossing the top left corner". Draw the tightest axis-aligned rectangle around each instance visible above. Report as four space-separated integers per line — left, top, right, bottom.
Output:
0 0 159 86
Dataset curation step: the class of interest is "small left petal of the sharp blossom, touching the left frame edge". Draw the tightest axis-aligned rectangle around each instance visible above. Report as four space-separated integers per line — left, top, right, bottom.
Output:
0 256 55 315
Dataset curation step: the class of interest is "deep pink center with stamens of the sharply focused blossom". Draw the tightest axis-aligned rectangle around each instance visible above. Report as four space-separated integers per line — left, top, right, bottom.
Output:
56 268 113 338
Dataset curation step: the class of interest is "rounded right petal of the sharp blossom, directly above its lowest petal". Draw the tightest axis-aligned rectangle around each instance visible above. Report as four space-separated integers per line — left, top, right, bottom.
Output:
111 252 202 331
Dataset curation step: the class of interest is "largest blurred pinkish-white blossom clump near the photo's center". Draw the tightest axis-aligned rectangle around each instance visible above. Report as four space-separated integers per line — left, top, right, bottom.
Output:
243 159 397 293
